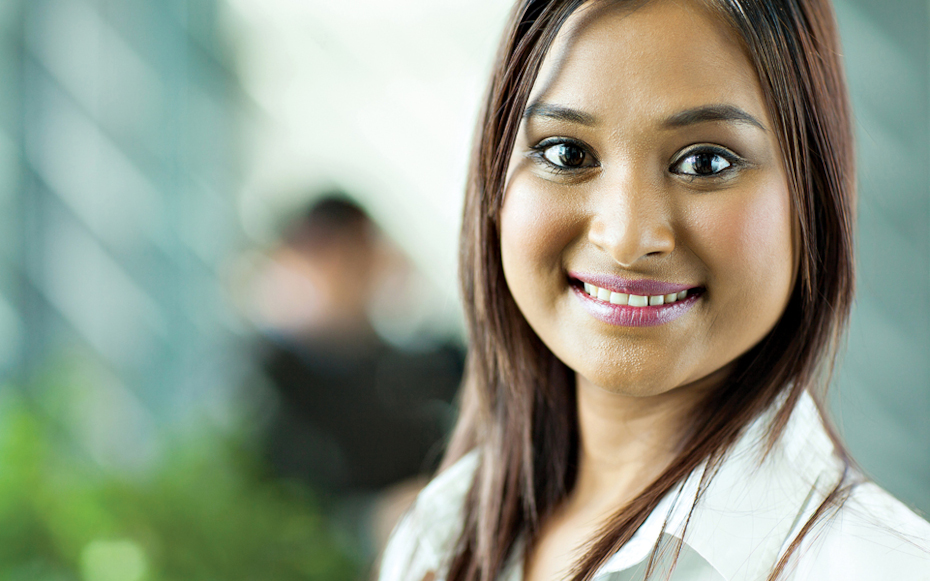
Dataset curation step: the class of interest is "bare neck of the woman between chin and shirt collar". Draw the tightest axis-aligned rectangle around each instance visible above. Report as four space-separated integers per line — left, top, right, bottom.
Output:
568 370 726 514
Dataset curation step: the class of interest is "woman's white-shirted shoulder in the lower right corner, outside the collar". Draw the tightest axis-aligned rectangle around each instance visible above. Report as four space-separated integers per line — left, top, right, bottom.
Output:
794 482 930 581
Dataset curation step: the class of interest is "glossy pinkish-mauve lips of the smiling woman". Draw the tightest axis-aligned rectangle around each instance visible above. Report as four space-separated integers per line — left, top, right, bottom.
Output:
569 272 702 327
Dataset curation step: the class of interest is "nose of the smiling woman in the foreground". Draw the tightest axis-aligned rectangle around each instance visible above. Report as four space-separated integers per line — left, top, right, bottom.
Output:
588 176 675 268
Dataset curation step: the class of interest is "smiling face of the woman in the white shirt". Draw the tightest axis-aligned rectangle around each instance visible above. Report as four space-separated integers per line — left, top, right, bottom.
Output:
500 0 797 395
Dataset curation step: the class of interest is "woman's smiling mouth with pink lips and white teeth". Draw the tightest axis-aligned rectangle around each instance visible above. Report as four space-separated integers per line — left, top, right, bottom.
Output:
570 273 703 327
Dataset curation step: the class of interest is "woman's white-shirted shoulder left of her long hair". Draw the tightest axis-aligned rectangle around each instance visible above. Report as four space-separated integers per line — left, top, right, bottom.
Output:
379 451 479 581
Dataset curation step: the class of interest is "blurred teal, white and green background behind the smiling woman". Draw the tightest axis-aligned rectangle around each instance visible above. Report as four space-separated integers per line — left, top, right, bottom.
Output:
0 0 930 581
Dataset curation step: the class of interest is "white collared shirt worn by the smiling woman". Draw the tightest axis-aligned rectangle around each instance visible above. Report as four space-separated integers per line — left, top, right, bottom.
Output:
380 394 930 581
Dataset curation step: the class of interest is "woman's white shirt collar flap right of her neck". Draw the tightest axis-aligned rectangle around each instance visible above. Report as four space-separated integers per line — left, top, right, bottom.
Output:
595 392 843 581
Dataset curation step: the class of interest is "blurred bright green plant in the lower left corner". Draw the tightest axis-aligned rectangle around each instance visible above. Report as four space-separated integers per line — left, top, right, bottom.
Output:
0 387 360 581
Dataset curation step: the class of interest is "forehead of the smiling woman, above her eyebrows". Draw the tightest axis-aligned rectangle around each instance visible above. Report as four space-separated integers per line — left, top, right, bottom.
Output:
530 0 767 125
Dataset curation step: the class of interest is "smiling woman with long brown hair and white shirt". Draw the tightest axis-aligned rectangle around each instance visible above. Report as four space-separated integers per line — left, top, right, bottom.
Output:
382 0 930 581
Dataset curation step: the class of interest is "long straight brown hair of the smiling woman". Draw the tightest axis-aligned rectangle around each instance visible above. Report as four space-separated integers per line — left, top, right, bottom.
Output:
444 0 855 581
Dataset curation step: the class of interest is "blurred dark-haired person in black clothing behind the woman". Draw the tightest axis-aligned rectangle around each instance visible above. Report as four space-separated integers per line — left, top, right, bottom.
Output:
243 191 463 572
